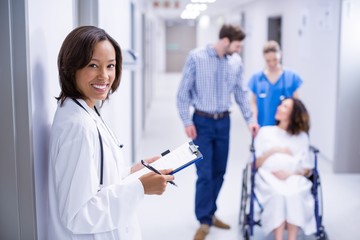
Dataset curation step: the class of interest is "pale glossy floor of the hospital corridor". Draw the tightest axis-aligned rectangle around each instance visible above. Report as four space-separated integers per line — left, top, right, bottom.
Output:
138 74 360 240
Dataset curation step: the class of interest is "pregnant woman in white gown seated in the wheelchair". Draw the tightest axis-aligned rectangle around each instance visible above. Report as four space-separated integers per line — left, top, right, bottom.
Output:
255 98 316 240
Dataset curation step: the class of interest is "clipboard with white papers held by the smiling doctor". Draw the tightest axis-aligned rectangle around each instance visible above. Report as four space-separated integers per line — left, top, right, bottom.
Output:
125 141 203 180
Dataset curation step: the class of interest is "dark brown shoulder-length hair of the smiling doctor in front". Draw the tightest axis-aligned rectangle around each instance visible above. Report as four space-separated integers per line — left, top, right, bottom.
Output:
56 26 122 105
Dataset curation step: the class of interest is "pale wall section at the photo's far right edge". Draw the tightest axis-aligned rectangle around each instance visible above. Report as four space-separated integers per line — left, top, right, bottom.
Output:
334 0 360 173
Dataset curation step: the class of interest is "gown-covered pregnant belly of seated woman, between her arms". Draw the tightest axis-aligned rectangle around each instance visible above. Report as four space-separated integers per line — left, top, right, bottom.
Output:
261 153 297 172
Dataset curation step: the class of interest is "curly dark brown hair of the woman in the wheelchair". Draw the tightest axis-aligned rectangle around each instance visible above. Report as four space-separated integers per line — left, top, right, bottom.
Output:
276 98 310 135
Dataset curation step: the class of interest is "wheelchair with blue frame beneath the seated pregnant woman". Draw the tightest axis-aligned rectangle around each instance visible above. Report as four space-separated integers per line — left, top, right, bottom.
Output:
239 137 328 240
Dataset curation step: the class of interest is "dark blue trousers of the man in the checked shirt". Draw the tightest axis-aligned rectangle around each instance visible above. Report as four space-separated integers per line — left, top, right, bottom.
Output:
193 114 230 225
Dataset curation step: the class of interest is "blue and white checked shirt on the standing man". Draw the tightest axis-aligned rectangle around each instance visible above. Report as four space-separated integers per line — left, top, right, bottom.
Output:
177 45 253 126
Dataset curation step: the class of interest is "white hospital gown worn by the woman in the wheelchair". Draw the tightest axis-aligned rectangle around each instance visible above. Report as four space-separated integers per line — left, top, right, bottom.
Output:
255 126 316 235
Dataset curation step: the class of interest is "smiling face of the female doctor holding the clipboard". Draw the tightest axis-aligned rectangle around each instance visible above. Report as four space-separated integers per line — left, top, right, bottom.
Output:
75 40 116 108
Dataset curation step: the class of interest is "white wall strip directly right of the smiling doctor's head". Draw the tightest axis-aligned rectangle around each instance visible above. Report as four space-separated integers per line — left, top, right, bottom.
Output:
99 0 150 163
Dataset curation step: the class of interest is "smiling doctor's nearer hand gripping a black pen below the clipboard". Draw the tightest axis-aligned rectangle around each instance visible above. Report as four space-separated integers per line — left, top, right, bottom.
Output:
139 169 174 195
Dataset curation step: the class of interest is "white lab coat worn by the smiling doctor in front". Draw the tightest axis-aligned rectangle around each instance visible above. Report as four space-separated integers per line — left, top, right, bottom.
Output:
48 99 144 240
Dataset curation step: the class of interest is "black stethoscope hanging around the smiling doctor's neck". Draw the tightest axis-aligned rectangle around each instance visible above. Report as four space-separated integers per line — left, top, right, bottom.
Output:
72 98 123 191
